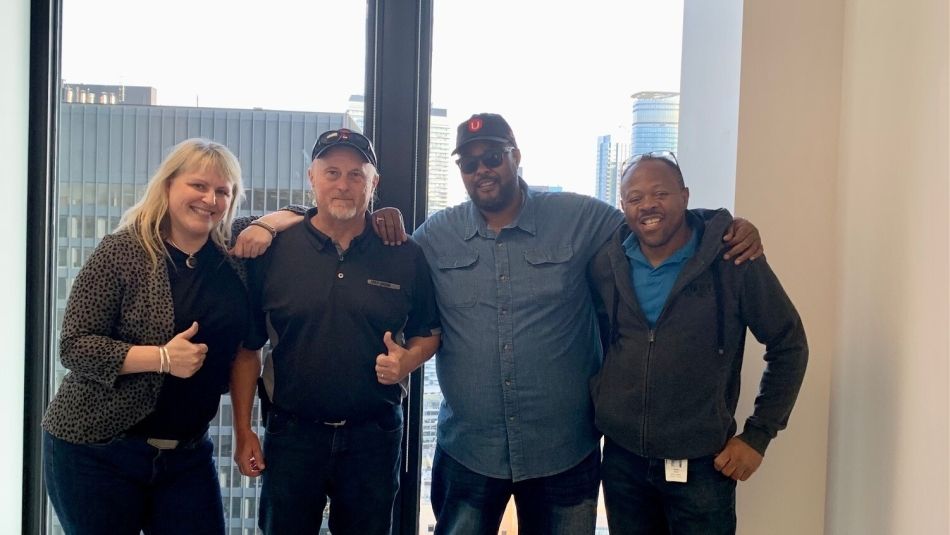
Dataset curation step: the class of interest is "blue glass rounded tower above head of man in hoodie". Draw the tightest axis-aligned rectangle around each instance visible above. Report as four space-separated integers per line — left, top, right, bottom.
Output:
630 91 680 155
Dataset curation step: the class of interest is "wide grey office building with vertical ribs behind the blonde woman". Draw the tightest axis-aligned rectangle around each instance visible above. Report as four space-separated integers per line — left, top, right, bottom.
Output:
51 97 358 535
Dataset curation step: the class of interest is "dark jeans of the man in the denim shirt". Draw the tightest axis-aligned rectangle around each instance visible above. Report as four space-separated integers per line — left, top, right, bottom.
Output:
432 447 600 535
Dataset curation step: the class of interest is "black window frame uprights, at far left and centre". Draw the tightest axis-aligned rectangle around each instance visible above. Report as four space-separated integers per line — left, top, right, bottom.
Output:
21 0 433 535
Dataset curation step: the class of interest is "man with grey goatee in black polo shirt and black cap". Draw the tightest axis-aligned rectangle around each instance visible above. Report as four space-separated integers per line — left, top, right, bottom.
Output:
231 129 440 535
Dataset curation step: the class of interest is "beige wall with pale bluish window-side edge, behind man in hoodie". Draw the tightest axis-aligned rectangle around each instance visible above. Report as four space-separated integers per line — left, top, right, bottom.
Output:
680 0 843 535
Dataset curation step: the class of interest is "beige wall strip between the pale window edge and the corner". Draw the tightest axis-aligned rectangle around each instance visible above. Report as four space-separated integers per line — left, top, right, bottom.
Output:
736 0 844 535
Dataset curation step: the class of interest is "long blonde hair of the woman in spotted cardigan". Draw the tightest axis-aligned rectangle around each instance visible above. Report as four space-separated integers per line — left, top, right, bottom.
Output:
117 138 244 269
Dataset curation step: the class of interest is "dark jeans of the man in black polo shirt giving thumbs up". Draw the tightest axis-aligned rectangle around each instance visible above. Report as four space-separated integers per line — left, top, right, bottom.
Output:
260 405 402 535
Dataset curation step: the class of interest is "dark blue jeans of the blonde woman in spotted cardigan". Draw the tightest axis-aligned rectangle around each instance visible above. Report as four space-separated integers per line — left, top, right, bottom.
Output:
43 432 224 535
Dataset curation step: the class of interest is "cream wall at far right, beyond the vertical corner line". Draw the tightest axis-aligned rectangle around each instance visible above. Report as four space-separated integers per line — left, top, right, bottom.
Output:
826 0 950 534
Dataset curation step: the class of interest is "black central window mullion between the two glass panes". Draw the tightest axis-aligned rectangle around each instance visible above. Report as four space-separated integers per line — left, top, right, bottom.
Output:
364 0 432 535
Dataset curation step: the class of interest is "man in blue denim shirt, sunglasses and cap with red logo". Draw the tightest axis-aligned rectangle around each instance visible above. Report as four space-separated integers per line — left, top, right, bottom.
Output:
413 113 761 535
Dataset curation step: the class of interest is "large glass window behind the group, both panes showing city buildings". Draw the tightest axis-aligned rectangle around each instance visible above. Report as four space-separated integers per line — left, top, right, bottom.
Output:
42 0 683 534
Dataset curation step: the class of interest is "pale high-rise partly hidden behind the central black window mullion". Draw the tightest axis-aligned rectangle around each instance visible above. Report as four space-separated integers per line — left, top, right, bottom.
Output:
346 95 452 215
